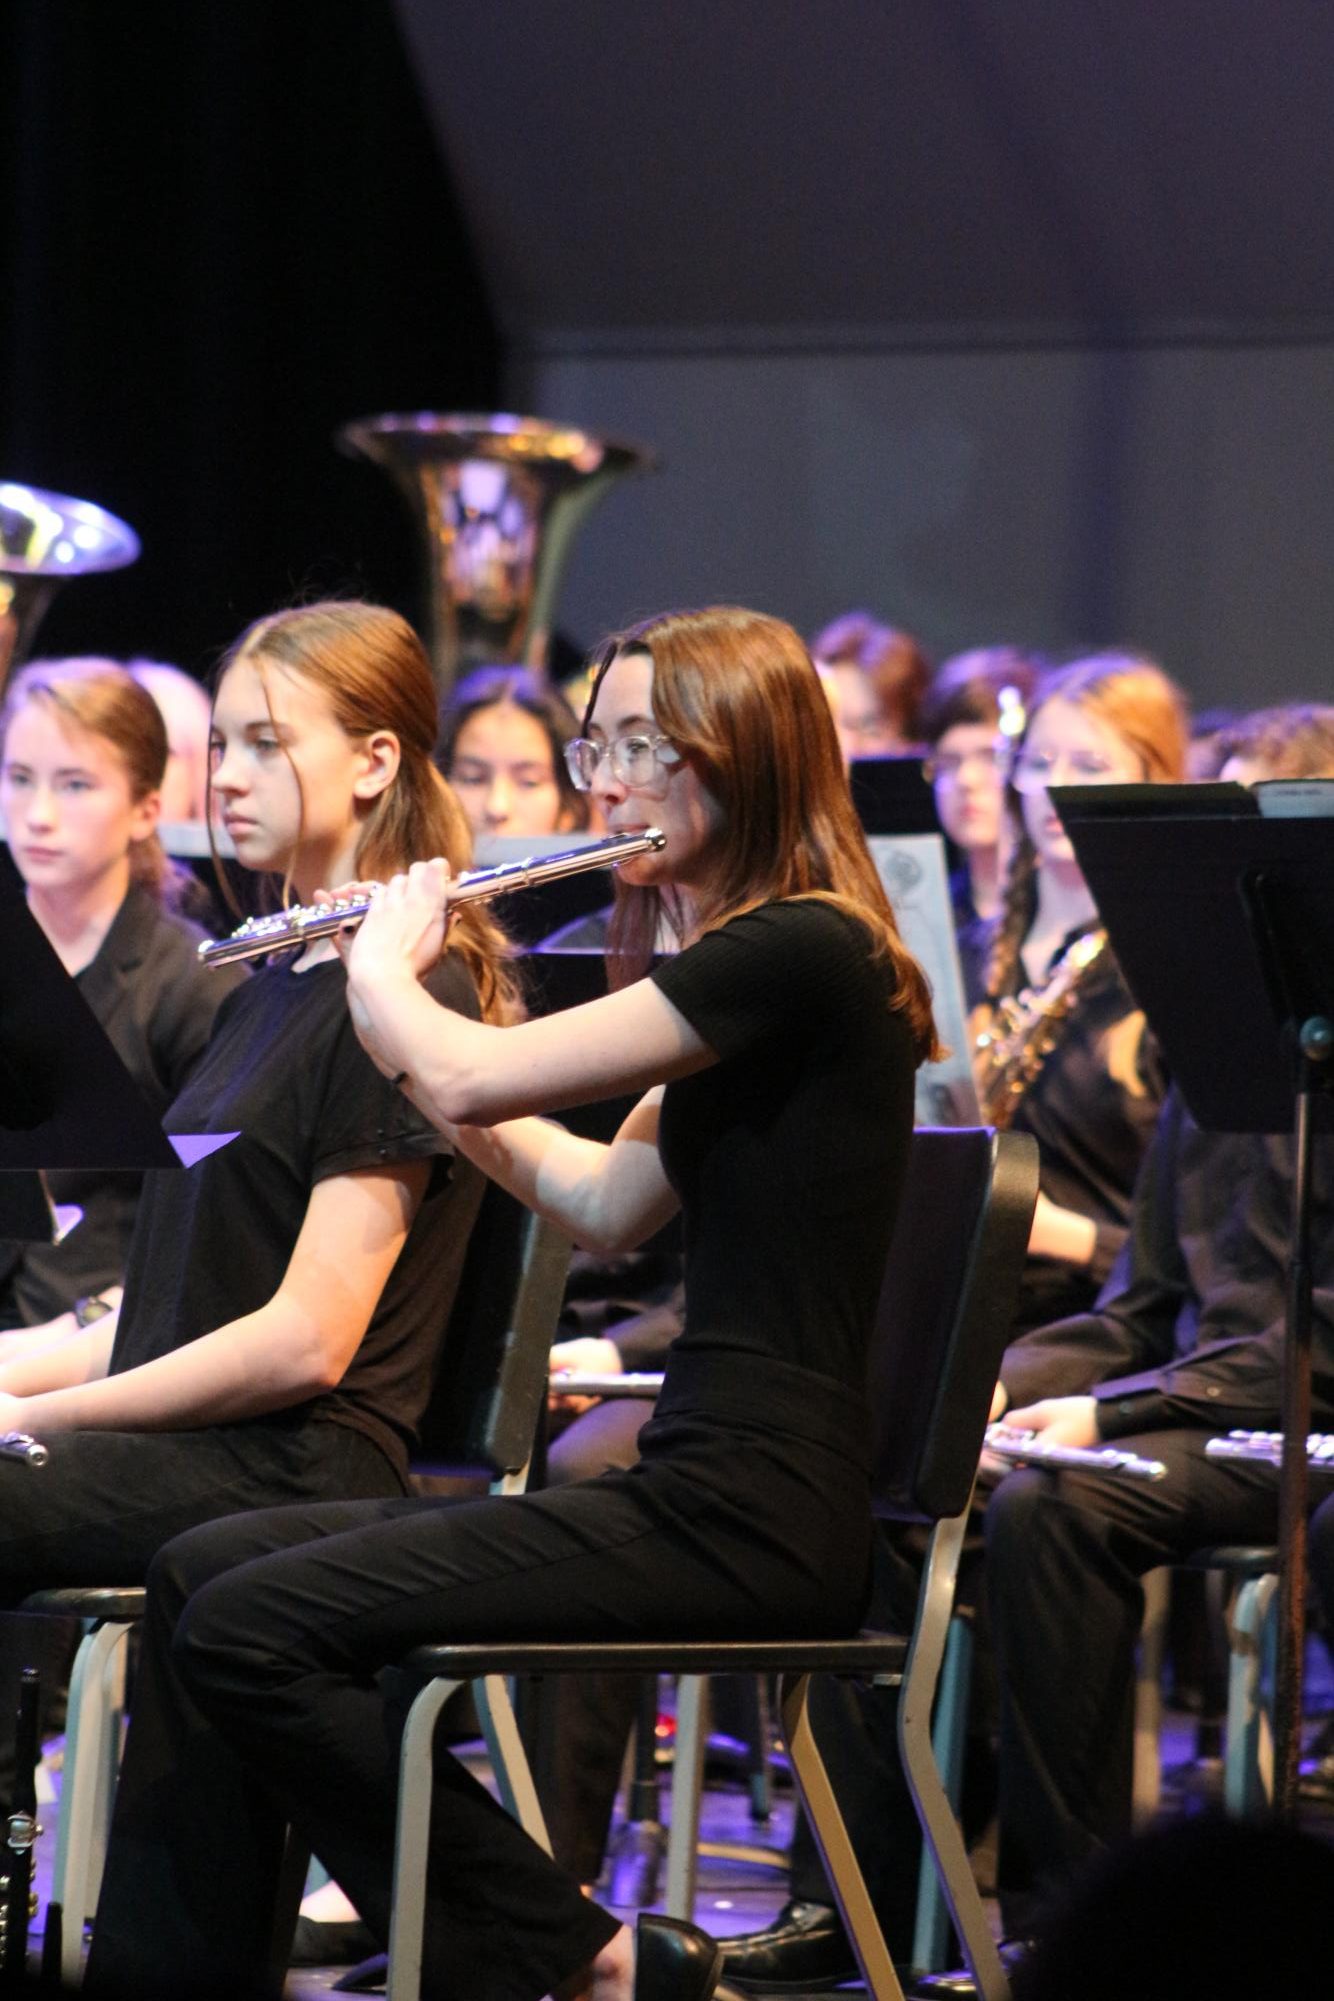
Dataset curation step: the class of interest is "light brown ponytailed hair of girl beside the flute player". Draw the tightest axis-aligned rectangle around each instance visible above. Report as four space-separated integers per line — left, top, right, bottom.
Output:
208 600 520 1021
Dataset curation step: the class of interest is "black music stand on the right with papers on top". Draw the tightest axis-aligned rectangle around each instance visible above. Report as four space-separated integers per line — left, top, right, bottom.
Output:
1052 784 1334 1815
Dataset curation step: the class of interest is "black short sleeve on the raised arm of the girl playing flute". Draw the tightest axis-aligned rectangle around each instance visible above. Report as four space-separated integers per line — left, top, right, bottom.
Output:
648 898 870 1057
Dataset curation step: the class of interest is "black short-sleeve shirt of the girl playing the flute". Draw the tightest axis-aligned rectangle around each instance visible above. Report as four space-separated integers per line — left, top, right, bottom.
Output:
650 898 916 1395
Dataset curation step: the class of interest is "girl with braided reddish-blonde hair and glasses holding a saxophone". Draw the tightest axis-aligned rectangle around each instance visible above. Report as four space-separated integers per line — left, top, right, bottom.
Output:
976 654 1188 1331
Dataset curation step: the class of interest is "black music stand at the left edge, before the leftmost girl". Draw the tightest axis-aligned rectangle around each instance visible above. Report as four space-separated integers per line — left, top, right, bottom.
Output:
0 882 180 1176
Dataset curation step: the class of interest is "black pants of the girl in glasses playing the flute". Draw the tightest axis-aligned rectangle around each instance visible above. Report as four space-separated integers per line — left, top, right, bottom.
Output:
88 1415 870 2001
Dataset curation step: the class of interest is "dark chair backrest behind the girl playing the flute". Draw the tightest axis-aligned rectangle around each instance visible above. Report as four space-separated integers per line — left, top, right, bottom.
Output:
870 1127 1038 1521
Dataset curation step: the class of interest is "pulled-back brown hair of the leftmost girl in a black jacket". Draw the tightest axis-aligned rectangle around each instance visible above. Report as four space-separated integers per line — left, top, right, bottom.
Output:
0 656 184 906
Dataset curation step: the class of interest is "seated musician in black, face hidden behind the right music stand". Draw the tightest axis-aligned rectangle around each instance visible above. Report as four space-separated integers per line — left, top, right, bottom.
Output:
724 708 1334 1993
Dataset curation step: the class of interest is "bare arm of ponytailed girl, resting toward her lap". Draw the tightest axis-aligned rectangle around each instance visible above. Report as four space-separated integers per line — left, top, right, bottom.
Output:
0 1161 430 1437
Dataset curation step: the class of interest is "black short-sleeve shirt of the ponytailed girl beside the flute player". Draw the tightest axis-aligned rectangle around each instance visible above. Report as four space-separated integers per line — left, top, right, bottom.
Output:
112 956 482 1469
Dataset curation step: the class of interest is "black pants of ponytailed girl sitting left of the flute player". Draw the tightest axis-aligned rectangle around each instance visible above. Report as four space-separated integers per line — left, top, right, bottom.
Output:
0 1421 402 1803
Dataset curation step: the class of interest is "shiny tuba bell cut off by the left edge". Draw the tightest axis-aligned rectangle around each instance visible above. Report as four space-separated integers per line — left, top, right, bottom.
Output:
0 480 138 692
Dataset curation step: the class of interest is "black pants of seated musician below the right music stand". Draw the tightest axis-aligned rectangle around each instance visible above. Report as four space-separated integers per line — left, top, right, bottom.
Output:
986 1431 1278 1933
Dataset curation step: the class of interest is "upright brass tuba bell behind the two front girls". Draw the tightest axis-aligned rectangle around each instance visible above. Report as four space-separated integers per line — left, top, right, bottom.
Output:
338 410 658 694
